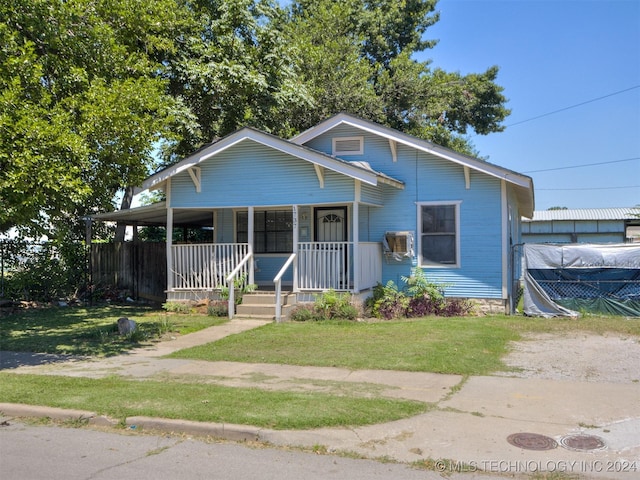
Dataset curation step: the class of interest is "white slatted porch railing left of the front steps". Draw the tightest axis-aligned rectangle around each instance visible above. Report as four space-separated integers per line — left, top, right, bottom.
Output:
171 243 249 290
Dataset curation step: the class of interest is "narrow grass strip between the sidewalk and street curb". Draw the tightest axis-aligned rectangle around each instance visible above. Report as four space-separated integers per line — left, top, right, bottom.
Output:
0 373 430 429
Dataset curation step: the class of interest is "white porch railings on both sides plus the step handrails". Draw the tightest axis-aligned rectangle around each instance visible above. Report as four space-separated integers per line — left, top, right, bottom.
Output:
167 242 383 320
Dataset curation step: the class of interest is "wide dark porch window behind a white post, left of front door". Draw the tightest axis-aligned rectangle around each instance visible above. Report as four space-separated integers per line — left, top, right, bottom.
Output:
236 210 293 253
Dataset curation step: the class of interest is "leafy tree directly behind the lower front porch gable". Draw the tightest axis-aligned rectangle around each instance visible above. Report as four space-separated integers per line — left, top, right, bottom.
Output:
167 0 310 158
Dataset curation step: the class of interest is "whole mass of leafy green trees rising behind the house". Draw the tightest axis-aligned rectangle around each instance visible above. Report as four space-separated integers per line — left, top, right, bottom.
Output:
0 0 508 239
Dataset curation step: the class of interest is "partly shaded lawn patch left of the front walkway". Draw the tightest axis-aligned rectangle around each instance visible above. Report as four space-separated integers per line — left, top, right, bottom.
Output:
0 305 226 356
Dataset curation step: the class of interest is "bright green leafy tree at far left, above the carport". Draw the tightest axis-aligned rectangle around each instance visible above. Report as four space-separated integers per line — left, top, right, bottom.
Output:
0 0 195 239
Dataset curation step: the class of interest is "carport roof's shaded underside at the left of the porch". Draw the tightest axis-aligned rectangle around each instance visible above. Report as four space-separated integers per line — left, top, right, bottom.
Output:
91 202 213 226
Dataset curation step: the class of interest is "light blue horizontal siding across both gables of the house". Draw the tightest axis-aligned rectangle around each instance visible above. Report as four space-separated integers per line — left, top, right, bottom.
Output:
162 125 520 298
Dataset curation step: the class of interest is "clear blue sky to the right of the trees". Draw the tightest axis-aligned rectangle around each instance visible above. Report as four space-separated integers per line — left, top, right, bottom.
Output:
416 0 640 210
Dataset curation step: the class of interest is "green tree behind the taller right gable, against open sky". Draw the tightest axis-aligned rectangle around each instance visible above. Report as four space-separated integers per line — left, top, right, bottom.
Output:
285 0 509 154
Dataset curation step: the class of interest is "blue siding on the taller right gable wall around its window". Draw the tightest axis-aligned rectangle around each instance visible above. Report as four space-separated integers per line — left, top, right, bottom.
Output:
309 126 510 298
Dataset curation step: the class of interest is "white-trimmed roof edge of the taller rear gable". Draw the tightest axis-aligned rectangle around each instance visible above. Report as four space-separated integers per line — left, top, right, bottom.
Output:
291 113 534 218
